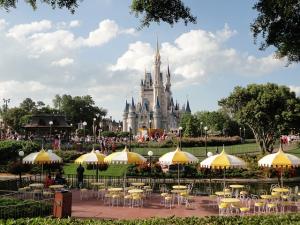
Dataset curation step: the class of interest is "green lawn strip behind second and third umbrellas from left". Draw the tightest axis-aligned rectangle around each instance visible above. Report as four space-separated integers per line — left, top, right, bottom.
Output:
64 163 127 177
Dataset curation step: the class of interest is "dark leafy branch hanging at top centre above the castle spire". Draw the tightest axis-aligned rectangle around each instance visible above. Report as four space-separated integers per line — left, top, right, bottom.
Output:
131 0 196 28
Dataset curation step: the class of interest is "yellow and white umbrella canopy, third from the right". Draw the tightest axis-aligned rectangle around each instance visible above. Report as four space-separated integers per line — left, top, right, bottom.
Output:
159 147 198 166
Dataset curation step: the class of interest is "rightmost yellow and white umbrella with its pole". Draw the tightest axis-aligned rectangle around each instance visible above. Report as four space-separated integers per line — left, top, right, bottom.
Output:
258 145 300 186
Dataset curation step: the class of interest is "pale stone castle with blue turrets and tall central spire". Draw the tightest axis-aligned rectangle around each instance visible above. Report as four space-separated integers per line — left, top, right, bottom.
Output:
123 41 191 134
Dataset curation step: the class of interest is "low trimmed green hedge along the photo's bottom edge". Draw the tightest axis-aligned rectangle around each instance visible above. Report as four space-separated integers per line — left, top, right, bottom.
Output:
0 214 300 225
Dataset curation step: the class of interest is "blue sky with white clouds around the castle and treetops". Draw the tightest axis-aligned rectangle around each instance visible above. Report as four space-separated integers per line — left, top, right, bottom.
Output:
0 0 300 120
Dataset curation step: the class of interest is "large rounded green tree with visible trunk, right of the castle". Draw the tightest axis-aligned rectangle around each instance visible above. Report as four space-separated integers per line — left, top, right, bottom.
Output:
219 83 300 153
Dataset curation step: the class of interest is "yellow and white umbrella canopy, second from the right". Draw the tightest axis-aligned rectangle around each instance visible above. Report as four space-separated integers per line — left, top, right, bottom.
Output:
200 147 246 169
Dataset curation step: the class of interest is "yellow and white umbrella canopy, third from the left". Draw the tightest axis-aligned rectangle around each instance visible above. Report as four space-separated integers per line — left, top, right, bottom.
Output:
104 146 147 164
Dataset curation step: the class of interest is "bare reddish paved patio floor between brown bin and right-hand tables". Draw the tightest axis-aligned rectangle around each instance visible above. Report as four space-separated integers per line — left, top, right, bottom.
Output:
72 190 218 219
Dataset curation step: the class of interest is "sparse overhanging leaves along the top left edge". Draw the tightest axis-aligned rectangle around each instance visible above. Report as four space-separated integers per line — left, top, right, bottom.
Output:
0 0 82 13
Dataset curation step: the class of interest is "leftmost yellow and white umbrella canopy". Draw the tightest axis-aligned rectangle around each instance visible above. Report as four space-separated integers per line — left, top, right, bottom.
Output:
23 149 62 164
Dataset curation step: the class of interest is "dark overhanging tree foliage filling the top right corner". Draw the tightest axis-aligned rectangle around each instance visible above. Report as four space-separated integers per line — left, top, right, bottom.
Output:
251 0 300 63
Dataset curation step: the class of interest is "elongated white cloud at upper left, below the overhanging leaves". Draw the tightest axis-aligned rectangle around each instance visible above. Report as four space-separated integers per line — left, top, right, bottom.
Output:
7 20 52 40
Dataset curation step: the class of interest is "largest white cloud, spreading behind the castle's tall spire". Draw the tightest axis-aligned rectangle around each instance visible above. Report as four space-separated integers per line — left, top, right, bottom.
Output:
108 24 285 86
